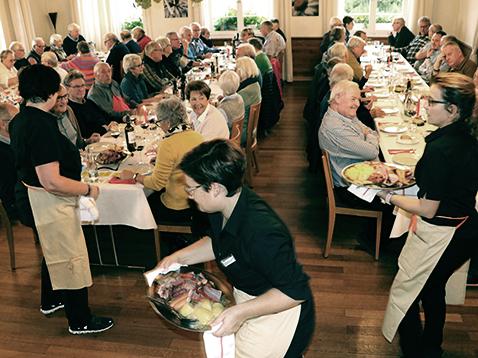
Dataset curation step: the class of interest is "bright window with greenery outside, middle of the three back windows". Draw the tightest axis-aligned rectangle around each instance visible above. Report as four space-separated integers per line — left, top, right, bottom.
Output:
203 0 273 36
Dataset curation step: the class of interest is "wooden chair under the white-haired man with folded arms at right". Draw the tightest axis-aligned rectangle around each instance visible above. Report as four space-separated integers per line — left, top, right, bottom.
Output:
322 151 382 260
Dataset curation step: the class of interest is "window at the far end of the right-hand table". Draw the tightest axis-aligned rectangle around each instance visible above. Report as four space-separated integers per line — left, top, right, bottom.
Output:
339 0 407 35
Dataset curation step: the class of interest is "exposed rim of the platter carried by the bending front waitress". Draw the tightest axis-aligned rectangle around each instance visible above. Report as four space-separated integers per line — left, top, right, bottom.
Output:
147 266 235 332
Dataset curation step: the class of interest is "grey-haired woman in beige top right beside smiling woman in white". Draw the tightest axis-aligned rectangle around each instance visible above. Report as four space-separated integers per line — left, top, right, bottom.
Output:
217 71 244 130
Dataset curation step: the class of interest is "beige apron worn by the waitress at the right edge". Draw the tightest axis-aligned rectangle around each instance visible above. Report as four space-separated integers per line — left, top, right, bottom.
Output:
382 217 468 342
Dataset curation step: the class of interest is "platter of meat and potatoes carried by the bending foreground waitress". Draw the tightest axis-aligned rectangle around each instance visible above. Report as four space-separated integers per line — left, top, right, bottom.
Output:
148 267 235 332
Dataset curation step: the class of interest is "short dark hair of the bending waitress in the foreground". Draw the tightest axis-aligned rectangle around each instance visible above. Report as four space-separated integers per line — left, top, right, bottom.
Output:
179 139 246 197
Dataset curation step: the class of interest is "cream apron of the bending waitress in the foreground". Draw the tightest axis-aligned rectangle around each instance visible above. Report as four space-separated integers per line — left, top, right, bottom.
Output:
234 288 301 358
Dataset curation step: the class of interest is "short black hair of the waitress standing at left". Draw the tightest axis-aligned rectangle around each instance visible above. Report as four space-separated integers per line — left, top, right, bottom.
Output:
18 64 61 103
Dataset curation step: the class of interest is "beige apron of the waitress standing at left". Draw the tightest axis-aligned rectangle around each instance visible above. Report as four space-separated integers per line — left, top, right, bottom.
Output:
27 186 93 290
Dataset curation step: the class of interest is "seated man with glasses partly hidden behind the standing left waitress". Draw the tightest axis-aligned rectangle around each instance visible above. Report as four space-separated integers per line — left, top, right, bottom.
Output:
51 85 101 149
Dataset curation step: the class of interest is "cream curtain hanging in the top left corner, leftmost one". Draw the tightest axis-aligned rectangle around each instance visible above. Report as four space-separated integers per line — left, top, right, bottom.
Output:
8 0 36 53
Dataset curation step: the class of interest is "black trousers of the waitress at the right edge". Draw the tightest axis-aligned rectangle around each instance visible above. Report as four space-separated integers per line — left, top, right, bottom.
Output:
398 217 478 358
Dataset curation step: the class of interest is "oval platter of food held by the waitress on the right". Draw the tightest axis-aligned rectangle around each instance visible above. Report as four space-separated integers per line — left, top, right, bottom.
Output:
342 161 415 190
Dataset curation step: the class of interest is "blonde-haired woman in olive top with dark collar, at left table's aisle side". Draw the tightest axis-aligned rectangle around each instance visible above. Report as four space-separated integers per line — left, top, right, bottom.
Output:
236 57 262 146
